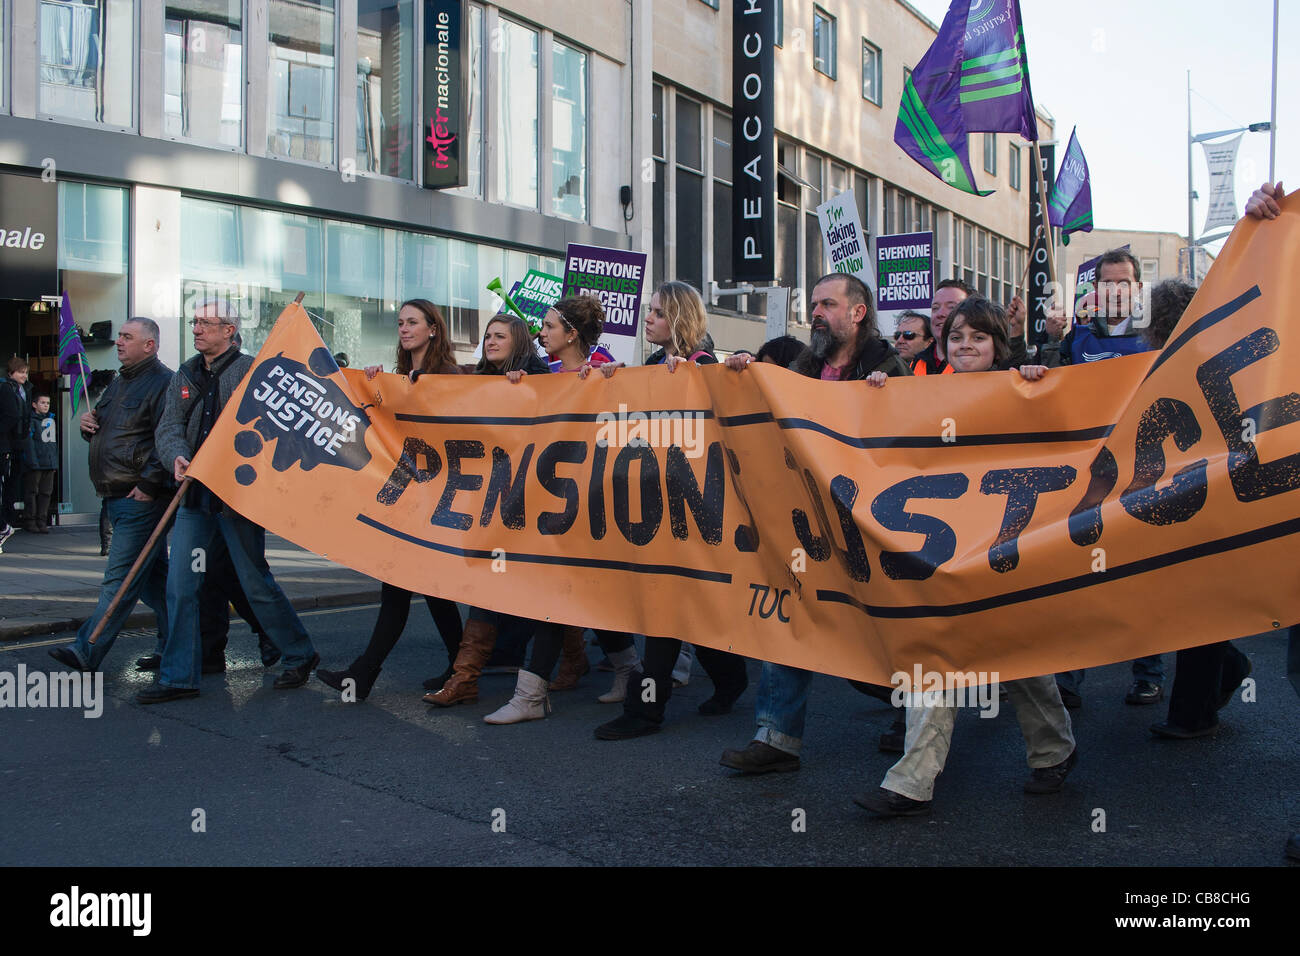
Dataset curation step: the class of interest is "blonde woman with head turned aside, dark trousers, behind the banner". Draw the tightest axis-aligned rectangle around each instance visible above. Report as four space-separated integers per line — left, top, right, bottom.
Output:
585 282 753 740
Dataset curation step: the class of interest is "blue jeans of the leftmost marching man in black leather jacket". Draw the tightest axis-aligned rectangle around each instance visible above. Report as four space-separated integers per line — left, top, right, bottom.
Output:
72 498 168 670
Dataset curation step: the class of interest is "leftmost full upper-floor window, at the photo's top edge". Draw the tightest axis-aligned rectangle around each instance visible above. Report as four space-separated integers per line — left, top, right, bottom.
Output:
38 0 135 129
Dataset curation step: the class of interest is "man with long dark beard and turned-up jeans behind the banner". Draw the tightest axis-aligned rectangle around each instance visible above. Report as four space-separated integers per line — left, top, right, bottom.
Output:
720 272 909 774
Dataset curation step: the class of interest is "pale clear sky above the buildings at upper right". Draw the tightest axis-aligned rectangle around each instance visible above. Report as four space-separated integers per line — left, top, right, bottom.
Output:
910 0 1300 252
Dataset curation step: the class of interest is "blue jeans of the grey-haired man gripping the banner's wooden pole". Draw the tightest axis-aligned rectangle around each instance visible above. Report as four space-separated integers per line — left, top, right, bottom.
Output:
159 507 316 689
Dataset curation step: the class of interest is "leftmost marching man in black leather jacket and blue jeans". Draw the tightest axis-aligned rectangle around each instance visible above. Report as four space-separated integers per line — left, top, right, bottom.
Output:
49 319 172 671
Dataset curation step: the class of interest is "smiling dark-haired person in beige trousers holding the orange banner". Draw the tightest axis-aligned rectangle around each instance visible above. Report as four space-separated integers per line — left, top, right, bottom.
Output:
854 295 1078 817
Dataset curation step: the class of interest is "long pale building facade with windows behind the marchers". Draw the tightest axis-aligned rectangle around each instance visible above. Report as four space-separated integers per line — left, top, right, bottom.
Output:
0 0 1052 515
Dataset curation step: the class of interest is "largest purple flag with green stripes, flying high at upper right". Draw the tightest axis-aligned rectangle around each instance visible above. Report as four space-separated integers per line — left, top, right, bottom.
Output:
894 0 1039 196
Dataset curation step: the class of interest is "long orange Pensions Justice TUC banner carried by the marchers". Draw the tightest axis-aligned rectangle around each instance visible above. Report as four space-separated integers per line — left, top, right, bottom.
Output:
190 198 1300 683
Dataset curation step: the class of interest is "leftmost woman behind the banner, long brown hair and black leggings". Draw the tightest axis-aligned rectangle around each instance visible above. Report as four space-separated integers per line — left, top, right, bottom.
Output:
316 299 462 701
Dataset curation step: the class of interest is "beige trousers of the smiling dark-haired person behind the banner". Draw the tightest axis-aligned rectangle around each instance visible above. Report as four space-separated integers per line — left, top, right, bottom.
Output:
880 676 1074 800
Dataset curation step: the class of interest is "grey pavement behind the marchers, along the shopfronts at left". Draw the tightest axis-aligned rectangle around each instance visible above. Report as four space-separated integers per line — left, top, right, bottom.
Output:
0 525 380 641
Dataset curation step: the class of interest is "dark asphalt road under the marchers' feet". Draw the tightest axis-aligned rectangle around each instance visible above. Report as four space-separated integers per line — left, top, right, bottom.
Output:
0 606 1300 866
